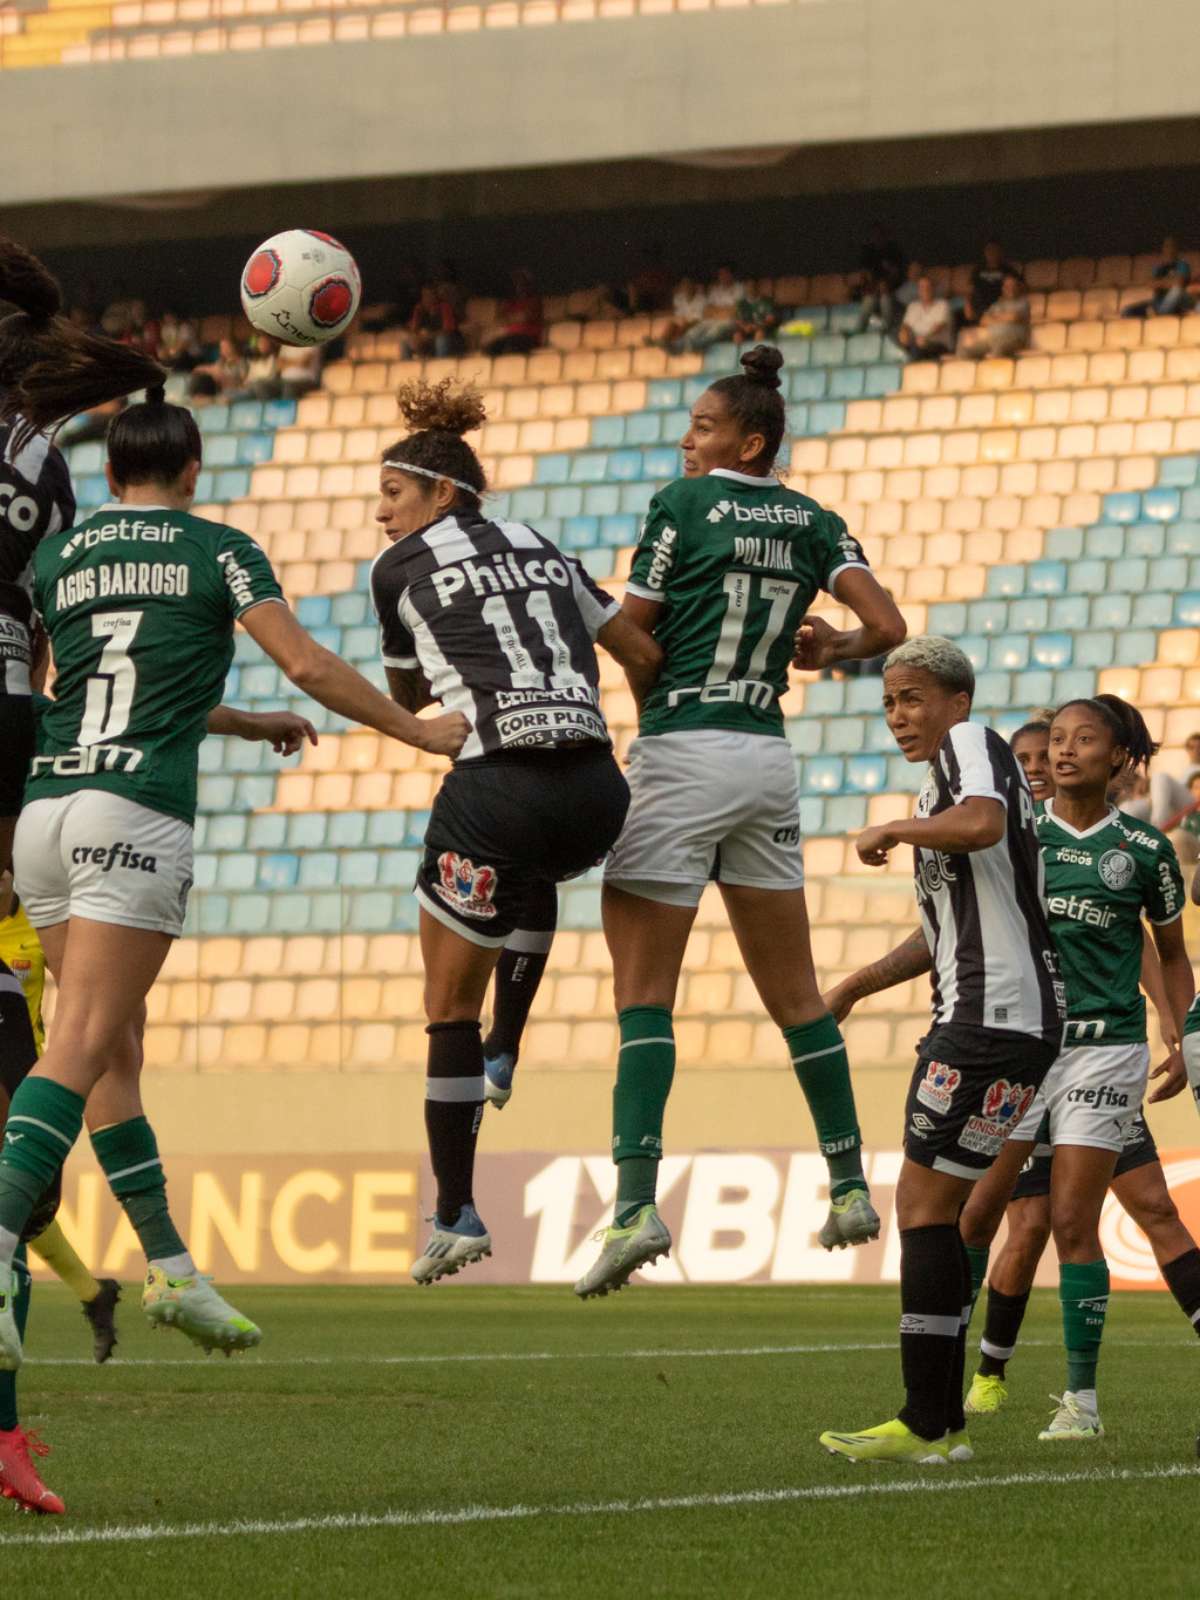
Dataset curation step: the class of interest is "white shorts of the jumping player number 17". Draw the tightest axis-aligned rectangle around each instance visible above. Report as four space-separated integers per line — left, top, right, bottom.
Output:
605 728 805 906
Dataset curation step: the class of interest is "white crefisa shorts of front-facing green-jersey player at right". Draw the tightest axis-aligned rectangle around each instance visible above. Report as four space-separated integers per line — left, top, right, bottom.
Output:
1010 1045 1150 1150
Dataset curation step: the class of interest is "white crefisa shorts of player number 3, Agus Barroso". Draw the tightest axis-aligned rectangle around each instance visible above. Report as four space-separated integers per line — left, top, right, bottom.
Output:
13 789 192 939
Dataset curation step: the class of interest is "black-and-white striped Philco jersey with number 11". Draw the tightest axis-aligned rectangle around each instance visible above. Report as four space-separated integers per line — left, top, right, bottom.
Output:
371 514 618 762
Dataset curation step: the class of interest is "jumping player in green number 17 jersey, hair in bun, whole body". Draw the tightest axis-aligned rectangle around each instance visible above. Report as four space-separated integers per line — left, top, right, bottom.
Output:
576 346 904 1298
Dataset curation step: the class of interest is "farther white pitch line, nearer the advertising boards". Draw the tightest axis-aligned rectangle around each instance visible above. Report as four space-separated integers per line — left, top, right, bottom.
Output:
24 1339 1195 1371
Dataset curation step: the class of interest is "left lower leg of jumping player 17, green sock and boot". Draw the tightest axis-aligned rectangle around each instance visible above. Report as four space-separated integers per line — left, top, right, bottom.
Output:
574 1005 675 1299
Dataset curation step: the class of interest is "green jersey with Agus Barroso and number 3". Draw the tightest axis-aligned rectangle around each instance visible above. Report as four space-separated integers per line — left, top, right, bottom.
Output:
26 506 283 822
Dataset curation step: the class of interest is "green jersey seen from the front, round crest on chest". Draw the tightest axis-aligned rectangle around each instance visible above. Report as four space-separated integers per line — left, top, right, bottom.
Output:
1037 800 1184 1045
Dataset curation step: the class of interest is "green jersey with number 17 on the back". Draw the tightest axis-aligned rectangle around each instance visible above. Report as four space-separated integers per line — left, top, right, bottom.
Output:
626 469 867 736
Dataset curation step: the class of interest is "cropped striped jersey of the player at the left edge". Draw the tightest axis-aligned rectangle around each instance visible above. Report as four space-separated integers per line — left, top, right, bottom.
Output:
0 419 75 694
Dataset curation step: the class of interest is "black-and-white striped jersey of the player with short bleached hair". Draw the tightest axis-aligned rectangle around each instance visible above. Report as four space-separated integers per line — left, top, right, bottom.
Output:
914 722 1066 1045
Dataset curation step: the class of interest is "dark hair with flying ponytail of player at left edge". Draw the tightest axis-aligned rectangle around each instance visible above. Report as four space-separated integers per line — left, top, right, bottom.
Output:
0 235 166 450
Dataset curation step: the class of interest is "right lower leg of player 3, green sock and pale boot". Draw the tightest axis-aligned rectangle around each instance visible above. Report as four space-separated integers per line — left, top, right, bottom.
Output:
91 1117 262 1355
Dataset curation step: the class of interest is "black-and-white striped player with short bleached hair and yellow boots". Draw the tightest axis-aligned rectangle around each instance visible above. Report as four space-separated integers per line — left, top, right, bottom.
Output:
821 638 1064 1462
